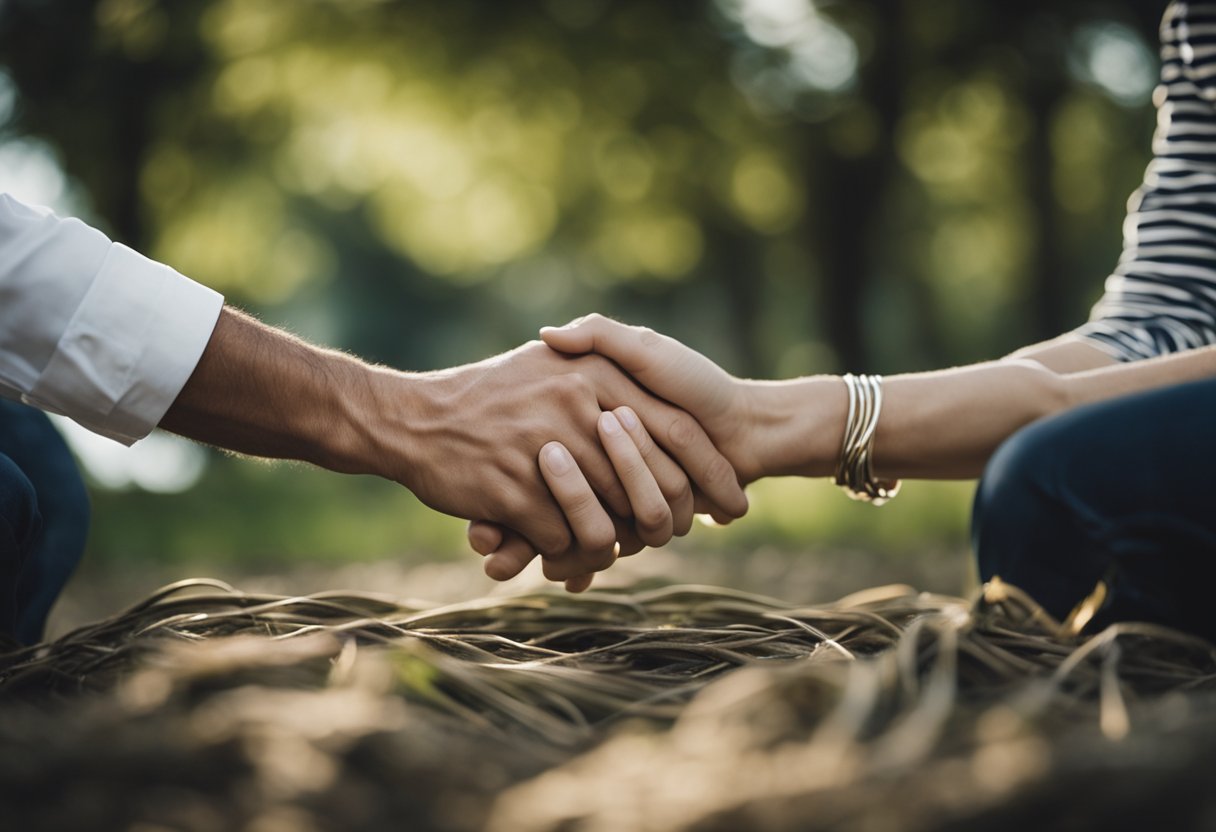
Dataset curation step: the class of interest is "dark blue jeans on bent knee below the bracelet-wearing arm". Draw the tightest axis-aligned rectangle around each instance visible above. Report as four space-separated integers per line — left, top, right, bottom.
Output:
972 380 1216 641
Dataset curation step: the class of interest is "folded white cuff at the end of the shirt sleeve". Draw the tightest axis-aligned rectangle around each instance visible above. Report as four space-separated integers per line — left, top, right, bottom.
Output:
22 243 224 445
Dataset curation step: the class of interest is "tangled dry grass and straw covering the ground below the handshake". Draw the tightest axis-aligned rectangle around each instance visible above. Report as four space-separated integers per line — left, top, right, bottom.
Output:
0 581 1216 832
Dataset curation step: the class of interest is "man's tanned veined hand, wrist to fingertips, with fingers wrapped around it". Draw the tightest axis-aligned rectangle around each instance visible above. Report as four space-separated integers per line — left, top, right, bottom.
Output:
365 342 747 574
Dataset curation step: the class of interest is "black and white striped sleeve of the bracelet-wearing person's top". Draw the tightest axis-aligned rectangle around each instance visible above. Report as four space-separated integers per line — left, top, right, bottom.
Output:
1076 1 1216 361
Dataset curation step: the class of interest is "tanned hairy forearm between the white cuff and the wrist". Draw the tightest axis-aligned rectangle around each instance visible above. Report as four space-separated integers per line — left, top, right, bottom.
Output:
161 308 376 473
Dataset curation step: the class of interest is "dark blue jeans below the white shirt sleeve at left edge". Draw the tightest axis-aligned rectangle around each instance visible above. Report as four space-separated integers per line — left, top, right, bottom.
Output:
0 399 89 645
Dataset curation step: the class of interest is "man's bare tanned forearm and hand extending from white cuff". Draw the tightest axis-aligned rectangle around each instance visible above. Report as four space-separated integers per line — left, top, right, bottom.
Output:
161 308 747 589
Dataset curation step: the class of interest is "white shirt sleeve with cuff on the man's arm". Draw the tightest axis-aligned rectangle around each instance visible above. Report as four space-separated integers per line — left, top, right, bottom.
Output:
0 193 224 445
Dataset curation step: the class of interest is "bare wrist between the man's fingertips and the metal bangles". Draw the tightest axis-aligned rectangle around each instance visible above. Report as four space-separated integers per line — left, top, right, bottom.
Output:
744 376 848 478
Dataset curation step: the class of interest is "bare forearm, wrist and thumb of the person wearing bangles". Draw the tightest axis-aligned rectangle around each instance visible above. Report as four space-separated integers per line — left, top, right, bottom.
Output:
541 315 1216 482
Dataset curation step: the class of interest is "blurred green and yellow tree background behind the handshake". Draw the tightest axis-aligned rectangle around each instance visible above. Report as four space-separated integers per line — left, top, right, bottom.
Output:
0 0 1165 610
